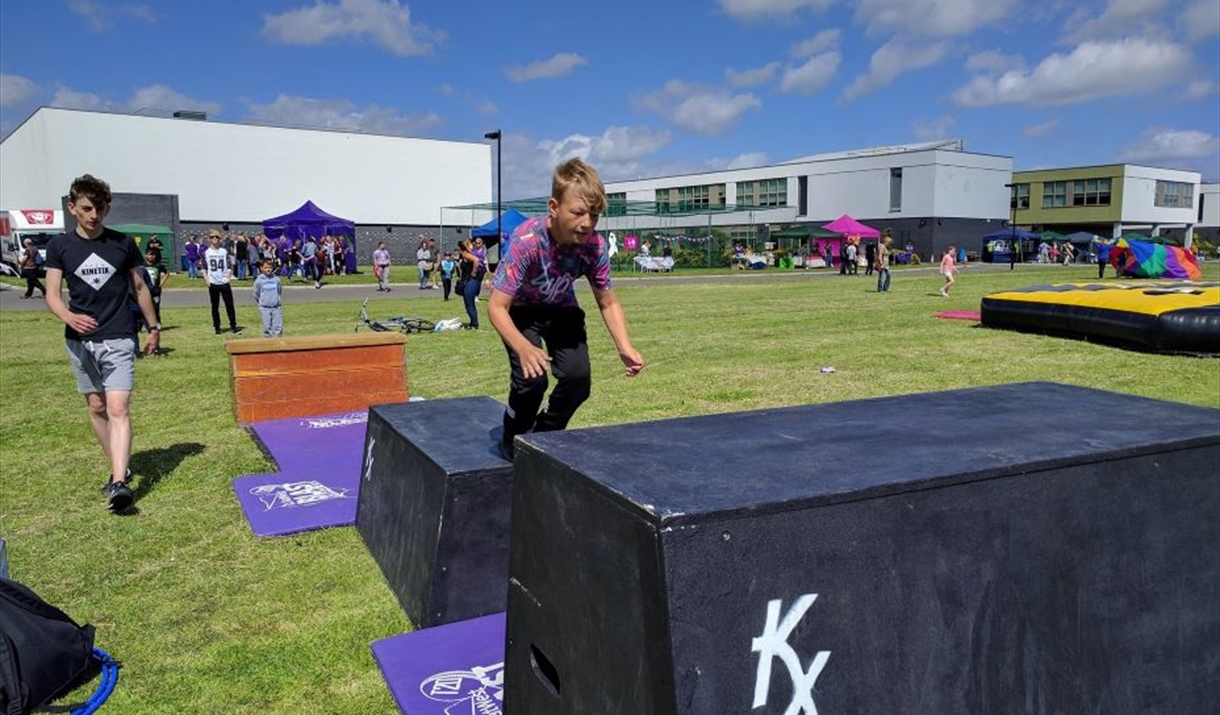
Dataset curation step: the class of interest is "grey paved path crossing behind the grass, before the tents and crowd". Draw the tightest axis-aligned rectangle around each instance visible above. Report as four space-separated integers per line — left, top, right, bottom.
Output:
0 258 1034 310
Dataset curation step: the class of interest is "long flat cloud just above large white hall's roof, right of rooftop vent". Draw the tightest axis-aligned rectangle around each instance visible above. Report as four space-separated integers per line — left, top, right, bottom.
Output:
246 94 444 137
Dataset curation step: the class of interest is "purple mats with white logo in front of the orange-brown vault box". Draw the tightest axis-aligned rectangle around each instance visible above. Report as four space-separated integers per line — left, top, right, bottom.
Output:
233 410 368 537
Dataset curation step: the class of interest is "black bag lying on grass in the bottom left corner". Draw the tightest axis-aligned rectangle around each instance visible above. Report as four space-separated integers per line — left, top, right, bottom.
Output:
0 578 98 715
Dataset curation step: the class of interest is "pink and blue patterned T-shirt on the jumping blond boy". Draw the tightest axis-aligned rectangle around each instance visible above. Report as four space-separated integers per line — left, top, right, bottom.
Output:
492 216 610 307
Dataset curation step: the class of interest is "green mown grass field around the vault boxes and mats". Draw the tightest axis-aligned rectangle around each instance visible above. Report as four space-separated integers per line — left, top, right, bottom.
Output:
0 264 1220 715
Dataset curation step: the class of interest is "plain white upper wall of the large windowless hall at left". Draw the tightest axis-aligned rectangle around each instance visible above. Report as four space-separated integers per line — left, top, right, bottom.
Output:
0 107 493 227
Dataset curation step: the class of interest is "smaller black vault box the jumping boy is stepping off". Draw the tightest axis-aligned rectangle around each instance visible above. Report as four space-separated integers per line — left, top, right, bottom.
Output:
356 398 512 628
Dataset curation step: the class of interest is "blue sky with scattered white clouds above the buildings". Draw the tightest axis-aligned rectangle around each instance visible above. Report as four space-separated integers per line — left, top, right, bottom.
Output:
0 0 1220 199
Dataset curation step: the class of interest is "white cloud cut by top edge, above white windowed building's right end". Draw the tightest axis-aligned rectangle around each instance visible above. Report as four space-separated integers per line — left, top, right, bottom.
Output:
855 0 1020 37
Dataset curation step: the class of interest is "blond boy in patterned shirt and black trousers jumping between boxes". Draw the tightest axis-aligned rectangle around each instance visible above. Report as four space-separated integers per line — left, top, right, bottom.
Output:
487 159 644 460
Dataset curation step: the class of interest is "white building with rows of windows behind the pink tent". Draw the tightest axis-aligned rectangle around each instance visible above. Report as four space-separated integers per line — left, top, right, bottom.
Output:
601 140 1013 256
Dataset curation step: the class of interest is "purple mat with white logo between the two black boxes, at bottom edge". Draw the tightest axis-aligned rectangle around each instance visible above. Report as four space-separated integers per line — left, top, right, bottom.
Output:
372 614 505 715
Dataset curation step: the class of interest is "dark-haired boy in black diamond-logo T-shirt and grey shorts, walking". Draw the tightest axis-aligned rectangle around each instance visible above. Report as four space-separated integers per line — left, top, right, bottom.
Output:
46 174 161 512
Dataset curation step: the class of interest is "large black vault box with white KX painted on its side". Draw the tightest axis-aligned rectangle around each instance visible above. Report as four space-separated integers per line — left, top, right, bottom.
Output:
505 383 1220 715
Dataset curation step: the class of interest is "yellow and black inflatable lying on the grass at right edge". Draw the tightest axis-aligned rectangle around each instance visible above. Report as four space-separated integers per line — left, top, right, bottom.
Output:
981 281 1220 355
